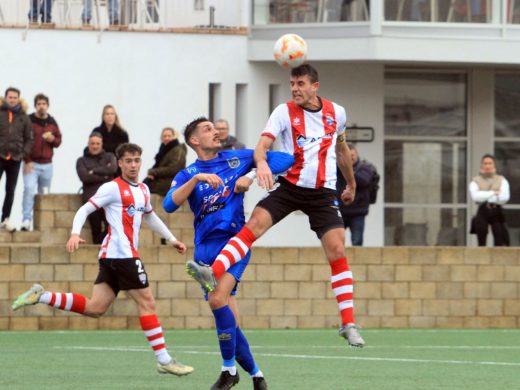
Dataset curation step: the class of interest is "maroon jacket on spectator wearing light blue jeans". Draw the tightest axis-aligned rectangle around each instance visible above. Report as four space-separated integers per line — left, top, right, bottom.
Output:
26 114 61 164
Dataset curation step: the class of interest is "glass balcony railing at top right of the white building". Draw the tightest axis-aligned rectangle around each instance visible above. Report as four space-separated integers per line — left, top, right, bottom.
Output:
253 0 520 26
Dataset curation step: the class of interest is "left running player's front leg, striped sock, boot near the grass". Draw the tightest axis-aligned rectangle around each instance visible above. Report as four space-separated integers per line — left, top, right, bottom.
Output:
127 287 193 375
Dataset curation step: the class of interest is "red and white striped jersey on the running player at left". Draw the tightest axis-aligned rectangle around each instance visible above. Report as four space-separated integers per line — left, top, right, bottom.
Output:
89 177 152 259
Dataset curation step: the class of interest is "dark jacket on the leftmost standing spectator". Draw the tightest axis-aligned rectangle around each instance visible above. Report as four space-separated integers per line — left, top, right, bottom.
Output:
0 98 33 161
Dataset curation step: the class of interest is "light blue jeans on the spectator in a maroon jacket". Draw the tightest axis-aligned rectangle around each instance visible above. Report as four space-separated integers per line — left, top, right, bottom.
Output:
22 162 52 221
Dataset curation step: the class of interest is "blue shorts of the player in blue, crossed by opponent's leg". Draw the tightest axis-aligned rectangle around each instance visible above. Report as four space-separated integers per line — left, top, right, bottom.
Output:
194 235 251 300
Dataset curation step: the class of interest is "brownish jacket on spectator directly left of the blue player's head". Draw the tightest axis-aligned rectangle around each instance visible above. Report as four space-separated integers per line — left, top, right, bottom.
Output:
146 140 188 196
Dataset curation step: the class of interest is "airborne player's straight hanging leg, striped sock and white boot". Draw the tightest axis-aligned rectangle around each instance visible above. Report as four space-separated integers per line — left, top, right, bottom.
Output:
321 228 365 347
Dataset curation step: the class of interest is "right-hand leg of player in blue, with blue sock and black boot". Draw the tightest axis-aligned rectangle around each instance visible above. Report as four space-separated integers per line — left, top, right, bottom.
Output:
229 295 267 390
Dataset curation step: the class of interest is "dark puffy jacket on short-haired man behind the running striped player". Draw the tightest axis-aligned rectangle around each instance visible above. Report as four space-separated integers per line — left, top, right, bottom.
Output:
76 149 117 202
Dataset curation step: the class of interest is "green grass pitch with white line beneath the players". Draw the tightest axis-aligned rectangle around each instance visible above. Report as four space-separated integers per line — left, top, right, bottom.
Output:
0 329 520 390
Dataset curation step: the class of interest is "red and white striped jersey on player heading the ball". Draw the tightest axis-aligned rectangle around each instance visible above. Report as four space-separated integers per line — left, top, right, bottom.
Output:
262 98 347 190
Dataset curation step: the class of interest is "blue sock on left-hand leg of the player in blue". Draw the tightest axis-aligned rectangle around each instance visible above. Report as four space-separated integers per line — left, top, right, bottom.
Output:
213 305 237 367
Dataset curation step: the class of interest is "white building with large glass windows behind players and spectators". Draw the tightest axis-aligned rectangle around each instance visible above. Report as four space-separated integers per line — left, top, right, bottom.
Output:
0 0 520 246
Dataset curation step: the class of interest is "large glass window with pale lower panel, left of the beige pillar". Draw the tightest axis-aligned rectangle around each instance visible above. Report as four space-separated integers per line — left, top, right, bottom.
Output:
384 71 468 245
